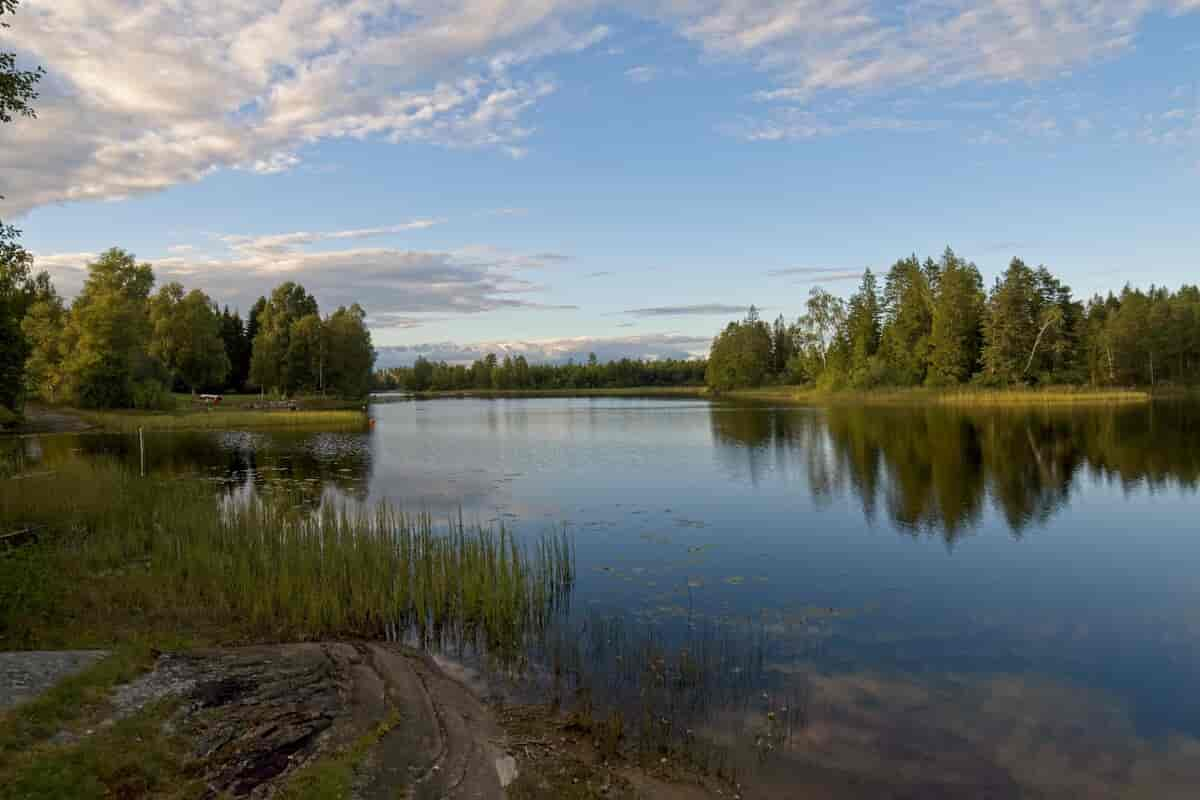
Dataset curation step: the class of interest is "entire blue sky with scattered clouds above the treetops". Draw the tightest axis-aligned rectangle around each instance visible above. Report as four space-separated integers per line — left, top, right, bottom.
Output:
0 0 1200 365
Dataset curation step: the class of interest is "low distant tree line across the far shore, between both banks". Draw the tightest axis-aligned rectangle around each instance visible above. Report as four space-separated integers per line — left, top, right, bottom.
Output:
376 353 707 391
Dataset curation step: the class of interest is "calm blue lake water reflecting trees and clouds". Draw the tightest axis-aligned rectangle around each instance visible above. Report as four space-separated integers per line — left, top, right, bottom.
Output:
9 398 1200 798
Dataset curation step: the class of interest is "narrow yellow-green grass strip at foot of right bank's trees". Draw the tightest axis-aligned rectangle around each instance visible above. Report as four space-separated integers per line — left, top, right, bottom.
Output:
721 386 1151 408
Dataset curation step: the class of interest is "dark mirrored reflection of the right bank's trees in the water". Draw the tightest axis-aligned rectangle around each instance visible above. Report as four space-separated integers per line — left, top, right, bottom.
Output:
712 403 1200 541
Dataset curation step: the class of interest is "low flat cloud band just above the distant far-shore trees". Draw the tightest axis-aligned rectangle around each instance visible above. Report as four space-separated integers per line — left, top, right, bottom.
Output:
377 333 712 367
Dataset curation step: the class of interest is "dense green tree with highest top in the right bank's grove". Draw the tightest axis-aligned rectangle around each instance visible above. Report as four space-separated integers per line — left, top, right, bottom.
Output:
925 247 986 386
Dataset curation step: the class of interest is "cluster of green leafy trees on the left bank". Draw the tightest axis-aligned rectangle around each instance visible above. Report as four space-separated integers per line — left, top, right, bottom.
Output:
0 246 374 409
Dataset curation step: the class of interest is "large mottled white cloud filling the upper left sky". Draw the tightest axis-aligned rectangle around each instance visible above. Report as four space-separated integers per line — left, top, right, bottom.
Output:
0 0 610 216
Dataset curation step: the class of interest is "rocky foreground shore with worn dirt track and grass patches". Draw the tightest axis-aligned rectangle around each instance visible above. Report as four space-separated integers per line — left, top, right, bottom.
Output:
0 639 734 800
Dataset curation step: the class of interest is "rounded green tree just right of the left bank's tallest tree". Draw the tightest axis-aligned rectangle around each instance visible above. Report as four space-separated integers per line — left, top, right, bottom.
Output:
150 282 229 392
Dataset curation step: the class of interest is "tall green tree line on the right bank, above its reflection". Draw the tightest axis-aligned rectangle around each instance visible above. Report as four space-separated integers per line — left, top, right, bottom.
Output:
706 248 1200 390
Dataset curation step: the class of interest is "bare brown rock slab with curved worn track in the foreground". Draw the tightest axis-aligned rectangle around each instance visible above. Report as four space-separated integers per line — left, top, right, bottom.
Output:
113 643 514 800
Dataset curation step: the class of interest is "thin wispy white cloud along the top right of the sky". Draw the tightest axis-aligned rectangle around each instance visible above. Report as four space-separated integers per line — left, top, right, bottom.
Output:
662 0 1185 101
